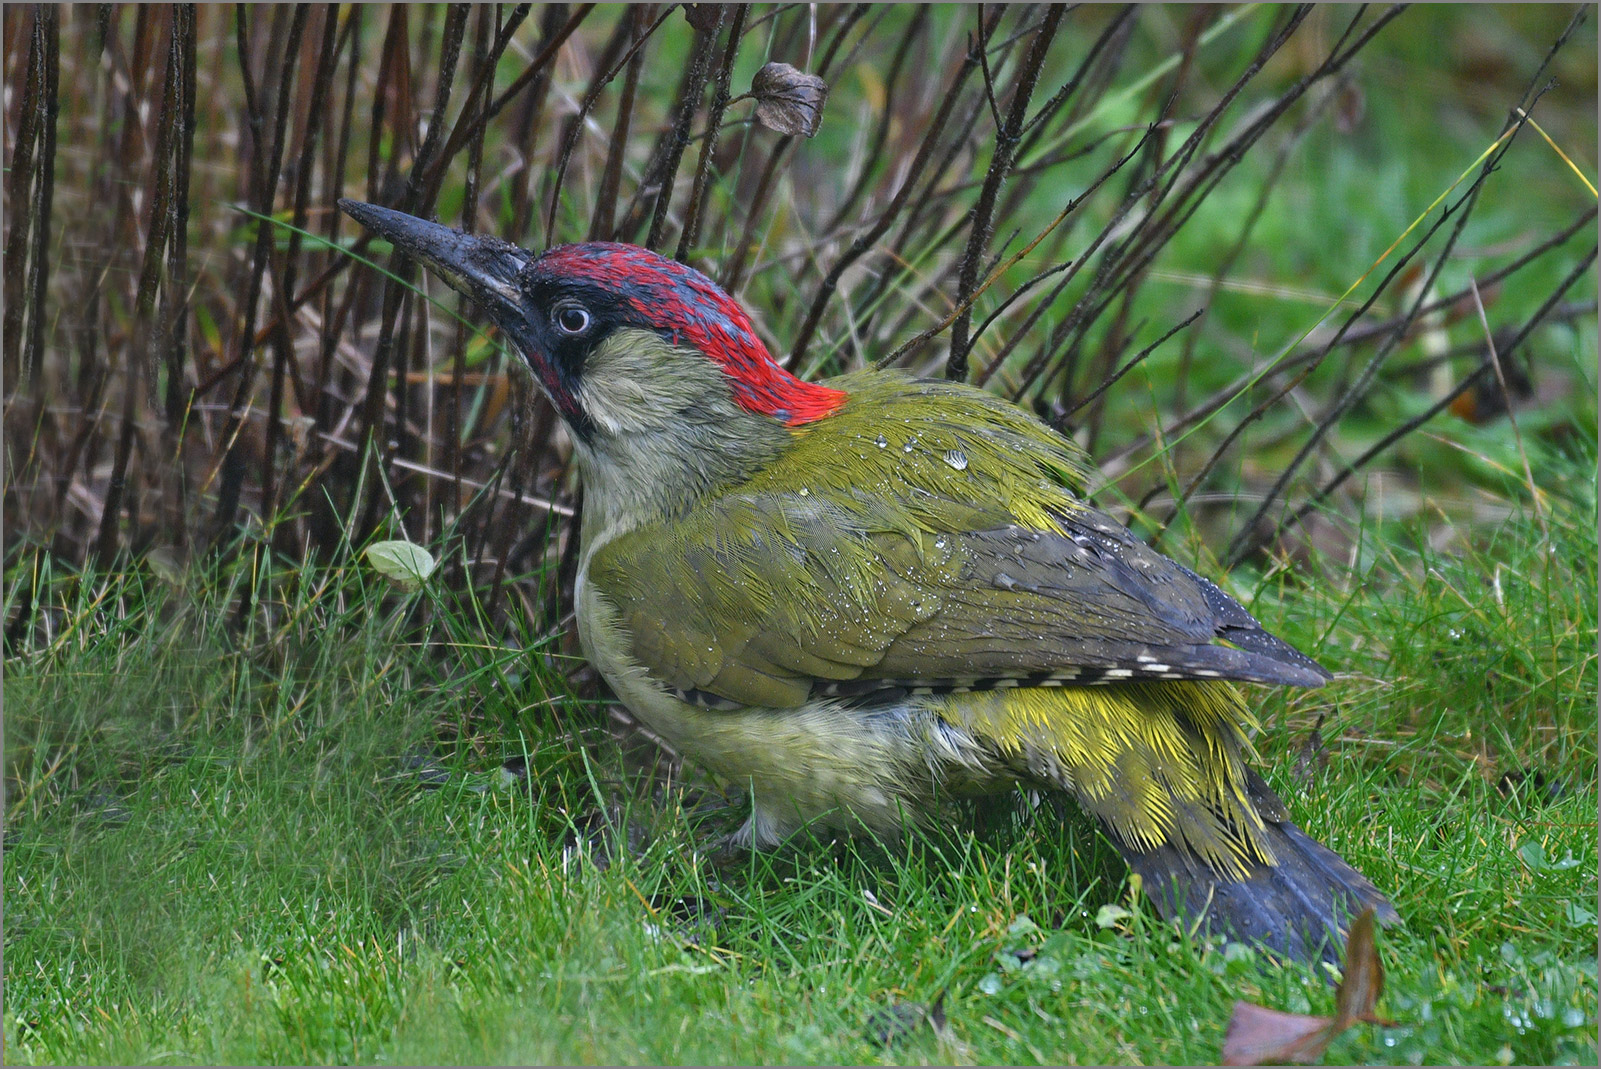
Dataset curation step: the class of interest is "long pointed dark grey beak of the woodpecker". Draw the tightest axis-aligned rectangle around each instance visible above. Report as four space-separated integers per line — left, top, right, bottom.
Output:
340 200 529 315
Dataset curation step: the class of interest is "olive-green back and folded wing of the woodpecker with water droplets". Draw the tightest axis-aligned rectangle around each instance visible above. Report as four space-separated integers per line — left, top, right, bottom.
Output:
590 373 1323 708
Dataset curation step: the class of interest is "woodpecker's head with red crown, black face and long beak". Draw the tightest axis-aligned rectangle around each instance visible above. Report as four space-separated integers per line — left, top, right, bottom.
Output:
340 200 846 440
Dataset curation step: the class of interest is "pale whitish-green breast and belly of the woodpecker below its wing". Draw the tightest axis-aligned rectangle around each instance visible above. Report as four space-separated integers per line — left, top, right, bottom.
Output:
574 567 1006 846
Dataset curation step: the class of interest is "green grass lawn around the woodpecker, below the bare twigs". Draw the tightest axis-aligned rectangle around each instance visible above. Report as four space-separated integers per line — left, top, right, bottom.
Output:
5 432 1599 1064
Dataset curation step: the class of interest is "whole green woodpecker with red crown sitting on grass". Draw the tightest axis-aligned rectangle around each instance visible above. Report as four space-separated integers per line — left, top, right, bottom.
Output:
340 200 1395 958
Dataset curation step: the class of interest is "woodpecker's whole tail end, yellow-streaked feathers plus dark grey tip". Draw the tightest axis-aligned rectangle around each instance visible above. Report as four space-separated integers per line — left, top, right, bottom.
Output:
942 681 1395 959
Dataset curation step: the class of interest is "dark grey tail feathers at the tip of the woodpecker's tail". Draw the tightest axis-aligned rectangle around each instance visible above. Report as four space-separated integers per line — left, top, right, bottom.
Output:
1113 822 1397 963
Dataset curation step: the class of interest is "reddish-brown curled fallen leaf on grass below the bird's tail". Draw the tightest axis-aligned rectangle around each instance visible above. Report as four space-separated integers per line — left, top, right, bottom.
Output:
1222 908 1394 1067
